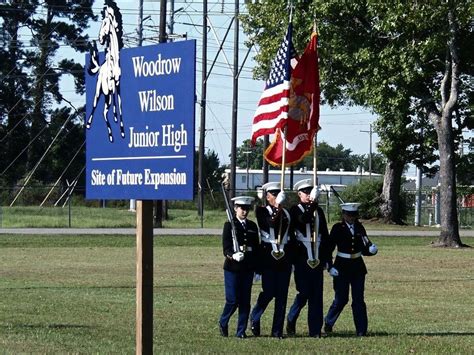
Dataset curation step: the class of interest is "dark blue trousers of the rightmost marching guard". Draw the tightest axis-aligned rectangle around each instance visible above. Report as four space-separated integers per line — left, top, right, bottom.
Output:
325 275 368 334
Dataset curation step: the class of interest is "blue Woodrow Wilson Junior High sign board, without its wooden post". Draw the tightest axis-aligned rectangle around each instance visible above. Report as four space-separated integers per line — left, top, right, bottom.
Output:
86 38 196 200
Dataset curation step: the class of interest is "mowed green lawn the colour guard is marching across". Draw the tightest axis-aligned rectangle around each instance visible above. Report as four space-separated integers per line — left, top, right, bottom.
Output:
0 235 474 354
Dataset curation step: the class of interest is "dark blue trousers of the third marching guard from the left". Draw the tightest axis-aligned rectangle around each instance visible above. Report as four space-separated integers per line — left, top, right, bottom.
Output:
288 262 323 336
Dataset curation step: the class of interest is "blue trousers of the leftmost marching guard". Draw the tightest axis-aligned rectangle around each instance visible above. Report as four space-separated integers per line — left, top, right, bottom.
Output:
219 270 253 336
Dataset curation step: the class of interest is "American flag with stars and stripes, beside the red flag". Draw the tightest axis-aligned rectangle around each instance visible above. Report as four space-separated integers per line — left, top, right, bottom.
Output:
252 23 296 144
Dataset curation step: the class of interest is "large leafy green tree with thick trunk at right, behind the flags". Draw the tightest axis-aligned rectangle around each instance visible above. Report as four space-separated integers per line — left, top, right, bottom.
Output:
243 0 474 246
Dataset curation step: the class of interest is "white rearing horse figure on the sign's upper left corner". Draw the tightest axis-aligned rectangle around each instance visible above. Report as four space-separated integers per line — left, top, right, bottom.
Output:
86 0 125 142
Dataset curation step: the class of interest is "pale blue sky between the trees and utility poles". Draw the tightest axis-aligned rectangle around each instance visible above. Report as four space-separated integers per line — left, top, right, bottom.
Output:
61 0 378 172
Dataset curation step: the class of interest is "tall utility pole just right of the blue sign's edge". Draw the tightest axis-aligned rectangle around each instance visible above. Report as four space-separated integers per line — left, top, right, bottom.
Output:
198 0 207 222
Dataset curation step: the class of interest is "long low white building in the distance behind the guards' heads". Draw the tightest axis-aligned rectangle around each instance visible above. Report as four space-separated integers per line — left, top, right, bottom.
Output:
225 168 383 190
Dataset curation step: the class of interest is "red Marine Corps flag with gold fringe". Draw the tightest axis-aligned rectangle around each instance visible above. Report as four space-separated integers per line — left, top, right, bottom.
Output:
264 32 320 166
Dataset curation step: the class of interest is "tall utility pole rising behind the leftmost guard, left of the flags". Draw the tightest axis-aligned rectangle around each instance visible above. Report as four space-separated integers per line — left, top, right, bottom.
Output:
230 0 239 197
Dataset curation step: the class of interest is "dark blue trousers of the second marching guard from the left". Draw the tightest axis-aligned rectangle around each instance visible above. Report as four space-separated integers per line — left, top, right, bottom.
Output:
251 268 291 336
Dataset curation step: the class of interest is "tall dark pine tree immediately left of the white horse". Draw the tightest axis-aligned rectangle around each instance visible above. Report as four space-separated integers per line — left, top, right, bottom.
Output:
22 0 97 180
